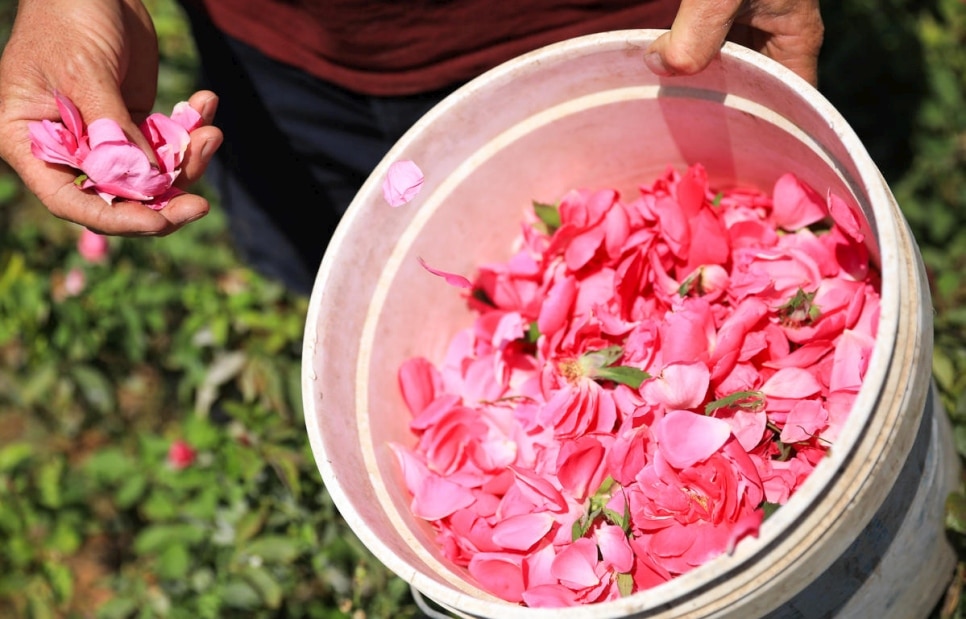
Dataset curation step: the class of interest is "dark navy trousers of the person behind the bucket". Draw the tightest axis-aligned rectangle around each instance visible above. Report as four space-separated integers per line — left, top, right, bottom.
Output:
186 3 455 294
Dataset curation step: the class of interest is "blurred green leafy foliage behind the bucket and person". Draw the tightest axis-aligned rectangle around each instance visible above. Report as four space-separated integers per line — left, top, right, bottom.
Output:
0 0 966 619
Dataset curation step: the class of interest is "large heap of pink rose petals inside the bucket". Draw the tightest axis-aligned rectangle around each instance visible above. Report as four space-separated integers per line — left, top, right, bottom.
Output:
393 165 880 607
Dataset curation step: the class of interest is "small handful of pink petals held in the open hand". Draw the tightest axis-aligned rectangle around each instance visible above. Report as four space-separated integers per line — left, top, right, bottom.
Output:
29 95 202 210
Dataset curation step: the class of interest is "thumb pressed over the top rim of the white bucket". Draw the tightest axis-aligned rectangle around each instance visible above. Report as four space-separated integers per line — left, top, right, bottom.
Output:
644 0 742 75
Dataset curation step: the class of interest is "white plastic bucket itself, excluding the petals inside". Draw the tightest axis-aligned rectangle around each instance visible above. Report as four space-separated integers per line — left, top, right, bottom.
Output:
302 30 958 619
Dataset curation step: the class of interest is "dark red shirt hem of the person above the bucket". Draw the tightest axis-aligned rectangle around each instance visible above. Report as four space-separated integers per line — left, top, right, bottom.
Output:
197 0 679 95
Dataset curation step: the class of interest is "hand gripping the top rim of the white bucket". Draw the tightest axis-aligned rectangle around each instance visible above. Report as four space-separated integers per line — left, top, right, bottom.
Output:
644 0 825 86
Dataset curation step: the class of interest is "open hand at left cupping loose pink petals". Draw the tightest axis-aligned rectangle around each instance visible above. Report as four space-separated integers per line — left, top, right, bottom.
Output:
0 0 222 236
